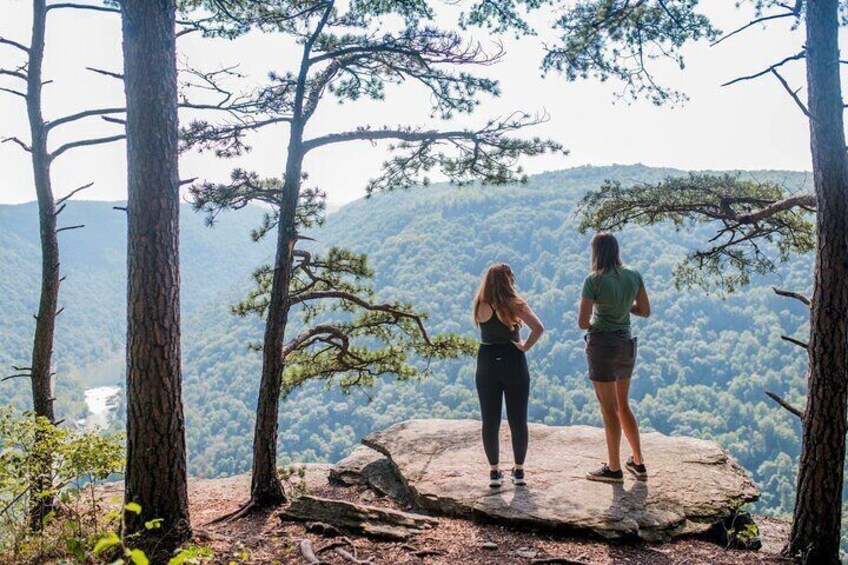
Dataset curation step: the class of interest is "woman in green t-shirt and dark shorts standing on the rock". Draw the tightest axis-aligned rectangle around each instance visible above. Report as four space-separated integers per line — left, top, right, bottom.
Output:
577 232 651 483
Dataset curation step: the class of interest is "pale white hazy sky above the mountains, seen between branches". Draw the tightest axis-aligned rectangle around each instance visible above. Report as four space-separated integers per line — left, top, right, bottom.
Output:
0 0 824 203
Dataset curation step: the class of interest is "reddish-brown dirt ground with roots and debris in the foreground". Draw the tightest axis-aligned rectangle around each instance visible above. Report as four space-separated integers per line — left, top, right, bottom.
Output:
112 465 788 565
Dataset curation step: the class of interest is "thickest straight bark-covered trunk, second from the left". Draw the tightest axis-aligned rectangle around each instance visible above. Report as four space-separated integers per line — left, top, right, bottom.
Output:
121 0 191 553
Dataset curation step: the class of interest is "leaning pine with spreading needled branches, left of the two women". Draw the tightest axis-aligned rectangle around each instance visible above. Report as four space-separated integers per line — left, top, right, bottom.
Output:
182 0 560 510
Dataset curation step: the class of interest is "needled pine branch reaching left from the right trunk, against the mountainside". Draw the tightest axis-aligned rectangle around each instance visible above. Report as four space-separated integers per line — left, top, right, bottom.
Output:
578 174 815 292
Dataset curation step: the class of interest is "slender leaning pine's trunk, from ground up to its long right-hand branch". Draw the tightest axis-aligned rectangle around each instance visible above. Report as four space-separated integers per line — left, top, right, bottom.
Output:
250 120 303 508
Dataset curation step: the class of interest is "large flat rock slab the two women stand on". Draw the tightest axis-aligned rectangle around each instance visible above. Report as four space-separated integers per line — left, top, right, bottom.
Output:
362 420 759 540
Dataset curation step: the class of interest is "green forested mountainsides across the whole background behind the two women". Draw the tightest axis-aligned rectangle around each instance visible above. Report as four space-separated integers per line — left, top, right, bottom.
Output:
0 166 812 512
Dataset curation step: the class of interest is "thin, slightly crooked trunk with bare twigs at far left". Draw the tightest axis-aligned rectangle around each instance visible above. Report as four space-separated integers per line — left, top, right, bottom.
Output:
26 0 59 529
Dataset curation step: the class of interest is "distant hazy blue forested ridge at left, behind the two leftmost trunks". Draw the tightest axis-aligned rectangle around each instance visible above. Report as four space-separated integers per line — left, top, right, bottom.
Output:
0 201 272 418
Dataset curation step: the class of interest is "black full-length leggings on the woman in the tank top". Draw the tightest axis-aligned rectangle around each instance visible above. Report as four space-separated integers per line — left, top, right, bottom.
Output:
476 343 530 465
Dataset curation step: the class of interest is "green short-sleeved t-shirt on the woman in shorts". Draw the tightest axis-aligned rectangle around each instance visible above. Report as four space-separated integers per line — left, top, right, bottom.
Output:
583 267 645 333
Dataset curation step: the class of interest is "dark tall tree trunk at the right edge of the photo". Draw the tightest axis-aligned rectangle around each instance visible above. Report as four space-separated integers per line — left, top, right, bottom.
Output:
787 0 848 564
